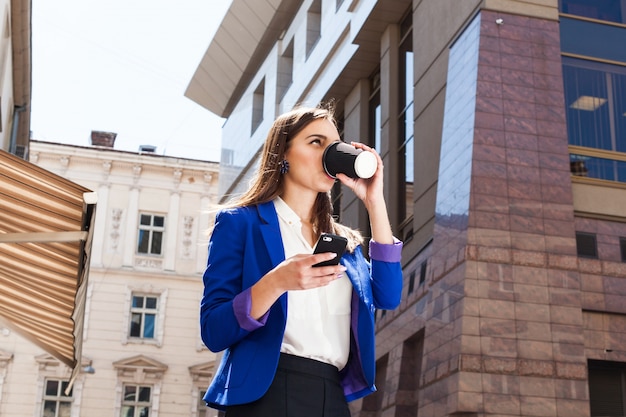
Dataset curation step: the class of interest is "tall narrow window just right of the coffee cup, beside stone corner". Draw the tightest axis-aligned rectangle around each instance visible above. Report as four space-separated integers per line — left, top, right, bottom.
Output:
398 10 413 229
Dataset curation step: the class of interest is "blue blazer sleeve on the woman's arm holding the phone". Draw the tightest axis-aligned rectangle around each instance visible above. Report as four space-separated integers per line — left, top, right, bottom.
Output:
200 209 267 352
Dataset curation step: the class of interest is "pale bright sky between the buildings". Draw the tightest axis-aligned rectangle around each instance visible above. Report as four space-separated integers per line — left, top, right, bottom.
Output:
31 0 231 161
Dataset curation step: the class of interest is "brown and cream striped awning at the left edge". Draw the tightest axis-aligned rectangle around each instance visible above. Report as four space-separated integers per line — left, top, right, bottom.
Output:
0 150 96 381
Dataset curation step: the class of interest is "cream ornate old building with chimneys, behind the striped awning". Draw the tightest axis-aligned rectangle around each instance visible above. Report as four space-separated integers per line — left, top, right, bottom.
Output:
0 132 218 417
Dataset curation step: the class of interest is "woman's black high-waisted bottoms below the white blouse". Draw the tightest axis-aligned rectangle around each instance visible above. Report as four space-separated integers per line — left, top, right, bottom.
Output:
225 353 350 417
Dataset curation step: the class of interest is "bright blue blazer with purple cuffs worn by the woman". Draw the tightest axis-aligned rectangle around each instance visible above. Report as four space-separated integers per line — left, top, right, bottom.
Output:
200 202 402 409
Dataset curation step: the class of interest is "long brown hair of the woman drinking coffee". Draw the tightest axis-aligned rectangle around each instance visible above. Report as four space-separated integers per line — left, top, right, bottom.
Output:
227 104 363 251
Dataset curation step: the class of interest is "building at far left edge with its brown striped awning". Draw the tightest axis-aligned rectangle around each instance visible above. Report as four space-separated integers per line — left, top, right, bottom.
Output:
0 0 101 409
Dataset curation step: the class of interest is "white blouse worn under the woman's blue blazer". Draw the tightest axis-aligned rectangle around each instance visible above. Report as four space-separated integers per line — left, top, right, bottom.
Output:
274 197 352 370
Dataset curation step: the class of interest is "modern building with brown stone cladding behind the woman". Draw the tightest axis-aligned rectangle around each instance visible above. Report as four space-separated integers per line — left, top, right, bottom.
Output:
186 0 626 417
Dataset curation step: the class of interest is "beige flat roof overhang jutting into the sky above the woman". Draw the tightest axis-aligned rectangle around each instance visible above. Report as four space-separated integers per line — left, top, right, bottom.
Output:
185 0 302 117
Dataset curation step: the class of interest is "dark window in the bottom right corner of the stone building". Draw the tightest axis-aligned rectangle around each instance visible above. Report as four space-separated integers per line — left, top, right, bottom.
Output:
589 360 626 417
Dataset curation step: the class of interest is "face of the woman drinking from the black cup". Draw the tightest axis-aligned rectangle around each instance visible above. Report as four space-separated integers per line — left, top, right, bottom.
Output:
284 119 340 194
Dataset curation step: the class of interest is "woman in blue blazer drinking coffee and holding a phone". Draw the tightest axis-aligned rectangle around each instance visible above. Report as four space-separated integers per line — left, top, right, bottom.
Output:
200 107 402 417
